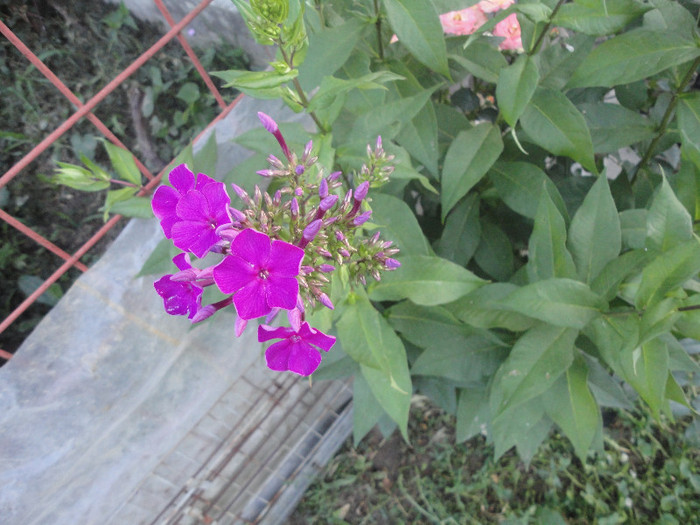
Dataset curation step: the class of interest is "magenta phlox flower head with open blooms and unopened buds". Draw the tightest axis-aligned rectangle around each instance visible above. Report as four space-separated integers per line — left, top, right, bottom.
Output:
152 113 400 376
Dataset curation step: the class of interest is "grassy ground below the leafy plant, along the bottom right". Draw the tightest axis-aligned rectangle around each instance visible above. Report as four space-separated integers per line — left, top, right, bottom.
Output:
290 401 700 525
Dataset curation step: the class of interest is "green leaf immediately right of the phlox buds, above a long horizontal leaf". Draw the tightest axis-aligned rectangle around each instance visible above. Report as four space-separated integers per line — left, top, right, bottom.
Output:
372 193 432 257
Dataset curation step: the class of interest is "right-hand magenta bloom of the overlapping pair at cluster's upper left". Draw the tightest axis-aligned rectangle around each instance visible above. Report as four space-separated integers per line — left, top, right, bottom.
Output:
172 177 231 258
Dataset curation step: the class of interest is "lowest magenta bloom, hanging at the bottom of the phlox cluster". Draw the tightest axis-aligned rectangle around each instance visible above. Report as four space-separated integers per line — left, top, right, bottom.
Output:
258 322 335 376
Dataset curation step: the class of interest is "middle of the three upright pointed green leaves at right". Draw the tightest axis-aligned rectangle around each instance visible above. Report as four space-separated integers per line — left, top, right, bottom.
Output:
567 176 622 283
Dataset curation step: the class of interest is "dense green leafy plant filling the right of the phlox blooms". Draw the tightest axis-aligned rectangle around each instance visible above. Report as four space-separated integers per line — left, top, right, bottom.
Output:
212 0 700 458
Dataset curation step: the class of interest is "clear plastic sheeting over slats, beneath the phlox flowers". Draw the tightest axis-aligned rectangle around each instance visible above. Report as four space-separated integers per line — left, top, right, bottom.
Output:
0 99 351 525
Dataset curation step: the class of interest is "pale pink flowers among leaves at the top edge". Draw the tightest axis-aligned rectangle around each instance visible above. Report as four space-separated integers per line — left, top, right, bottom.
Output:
440 0 523 51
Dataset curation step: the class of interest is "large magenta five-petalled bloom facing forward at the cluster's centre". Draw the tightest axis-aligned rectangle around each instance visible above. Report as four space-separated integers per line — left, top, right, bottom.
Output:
214 228 304 320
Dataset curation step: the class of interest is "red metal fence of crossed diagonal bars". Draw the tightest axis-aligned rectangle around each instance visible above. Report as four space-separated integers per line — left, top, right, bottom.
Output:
0 0 240 363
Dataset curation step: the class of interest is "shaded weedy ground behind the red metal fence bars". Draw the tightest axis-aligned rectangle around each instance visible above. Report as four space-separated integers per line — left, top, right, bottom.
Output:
0 0 247 356
